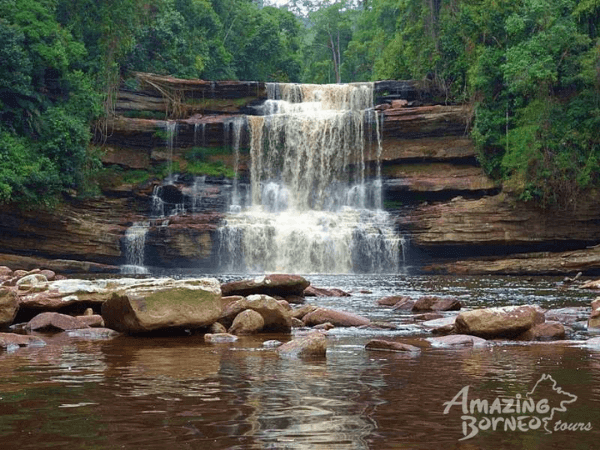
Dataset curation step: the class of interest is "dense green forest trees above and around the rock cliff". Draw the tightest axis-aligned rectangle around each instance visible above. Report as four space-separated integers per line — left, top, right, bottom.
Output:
0 0 600 206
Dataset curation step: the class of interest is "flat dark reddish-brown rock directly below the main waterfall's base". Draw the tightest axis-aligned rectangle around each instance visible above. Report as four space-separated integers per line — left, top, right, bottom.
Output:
221 274 310 297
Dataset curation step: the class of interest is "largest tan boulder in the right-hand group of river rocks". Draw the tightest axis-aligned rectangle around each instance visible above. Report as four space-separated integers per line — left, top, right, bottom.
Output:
455 306 544 338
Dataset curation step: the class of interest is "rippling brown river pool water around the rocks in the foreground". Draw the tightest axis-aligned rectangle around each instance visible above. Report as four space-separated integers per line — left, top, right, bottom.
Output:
0 276 600 450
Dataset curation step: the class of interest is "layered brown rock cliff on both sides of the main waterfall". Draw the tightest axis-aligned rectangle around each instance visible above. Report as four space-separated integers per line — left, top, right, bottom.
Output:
0 74 600 273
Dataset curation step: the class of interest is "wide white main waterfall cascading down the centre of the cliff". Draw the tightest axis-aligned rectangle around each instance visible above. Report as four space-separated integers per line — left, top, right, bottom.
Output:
219 83 402 273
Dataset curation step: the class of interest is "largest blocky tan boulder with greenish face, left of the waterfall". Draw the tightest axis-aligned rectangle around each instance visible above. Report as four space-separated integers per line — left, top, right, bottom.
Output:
102 278 222 334
